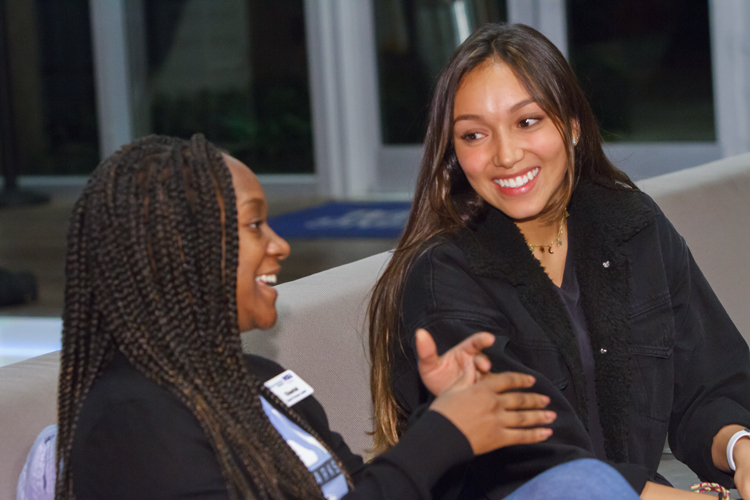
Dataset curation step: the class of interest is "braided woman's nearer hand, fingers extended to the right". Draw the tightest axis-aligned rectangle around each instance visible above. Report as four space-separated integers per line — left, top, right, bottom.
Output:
430 366 557 455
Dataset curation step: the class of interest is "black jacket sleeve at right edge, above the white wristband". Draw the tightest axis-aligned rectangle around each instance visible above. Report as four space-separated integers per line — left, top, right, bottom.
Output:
657 208 750 487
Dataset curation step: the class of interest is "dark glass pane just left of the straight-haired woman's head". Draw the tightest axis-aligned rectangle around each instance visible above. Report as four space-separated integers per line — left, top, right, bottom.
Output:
375 0 507 144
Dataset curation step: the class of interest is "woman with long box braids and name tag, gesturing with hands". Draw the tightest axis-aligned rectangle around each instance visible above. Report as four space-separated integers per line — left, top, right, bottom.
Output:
48 135 648 500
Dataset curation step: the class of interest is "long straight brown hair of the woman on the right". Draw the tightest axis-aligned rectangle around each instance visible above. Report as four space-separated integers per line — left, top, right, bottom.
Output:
368 24 635 452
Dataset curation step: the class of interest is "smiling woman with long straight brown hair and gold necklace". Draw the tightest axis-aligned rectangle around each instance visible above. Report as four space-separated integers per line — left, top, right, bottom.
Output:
369 24 750 498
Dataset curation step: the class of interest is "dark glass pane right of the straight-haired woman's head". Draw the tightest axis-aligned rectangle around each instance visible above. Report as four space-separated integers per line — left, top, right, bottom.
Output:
568 0 716 142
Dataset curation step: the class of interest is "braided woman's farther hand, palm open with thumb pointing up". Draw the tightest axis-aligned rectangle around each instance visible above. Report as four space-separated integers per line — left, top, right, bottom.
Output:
416 328 495 396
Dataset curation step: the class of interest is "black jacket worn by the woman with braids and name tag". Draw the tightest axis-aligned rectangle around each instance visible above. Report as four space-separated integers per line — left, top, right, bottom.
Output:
71 354 473 500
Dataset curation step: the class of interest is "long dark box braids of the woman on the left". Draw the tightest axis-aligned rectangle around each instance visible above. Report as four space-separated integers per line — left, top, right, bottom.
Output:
55 135 351 500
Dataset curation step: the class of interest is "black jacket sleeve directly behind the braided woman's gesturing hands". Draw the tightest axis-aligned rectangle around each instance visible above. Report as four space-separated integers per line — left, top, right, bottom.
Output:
392 243 648 498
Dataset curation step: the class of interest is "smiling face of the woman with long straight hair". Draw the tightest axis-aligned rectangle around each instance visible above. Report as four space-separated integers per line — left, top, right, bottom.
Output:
453 60 577 222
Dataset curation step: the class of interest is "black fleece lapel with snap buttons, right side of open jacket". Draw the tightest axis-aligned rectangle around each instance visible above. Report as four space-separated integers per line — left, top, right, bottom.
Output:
569 183 654 462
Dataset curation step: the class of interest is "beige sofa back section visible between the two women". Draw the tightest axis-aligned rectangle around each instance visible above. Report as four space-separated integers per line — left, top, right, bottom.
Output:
242 252 390 454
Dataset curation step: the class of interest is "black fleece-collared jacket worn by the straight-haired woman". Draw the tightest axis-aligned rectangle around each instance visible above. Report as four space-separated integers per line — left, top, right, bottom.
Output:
392 181 750 498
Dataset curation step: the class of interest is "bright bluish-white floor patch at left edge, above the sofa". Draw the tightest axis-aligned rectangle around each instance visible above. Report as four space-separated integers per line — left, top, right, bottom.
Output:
0 316 62 366
